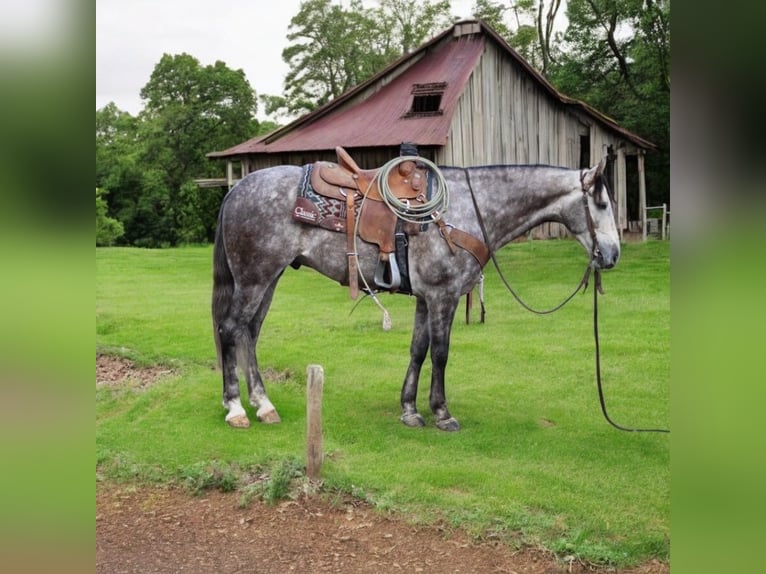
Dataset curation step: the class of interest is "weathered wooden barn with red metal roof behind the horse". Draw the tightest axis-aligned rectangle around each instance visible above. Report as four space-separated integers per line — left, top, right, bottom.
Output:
208 20 654 237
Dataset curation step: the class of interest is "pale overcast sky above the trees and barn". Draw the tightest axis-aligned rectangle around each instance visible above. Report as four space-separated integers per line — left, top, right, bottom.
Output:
96 0 474 119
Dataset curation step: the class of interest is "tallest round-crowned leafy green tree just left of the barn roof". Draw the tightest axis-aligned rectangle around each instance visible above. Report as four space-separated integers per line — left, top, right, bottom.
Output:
138 53 258 245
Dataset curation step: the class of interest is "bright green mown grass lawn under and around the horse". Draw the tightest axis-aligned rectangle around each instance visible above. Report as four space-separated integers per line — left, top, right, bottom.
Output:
96 241 670 566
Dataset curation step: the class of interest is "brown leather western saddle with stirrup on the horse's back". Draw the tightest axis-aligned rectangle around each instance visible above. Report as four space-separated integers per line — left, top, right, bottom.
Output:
311 147 436 298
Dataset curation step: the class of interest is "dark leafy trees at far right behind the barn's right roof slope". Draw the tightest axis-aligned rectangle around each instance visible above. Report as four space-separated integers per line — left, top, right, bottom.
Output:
551 0 670 204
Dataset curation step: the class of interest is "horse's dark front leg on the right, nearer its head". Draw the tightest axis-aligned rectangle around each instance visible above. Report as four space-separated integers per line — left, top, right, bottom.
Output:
428 298 460 431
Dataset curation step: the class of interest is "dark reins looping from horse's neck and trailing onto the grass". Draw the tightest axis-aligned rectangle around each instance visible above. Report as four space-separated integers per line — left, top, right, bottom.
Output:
463 168 670 433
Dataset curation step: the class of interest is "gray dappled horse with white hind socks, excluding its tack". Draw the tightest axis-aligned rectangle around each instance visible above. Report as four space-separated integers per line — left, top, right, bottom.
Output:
212 160 620 431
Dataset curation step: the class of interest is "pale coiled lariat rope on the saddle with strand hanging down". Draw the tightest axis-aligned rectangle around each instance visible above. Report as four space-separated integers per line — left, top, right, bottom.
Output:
351 155 449 331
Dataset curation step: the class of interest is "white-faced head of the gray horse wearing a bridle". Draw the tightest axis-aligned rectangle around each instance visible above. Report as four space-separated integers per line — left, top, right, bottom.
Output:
575 157 620 269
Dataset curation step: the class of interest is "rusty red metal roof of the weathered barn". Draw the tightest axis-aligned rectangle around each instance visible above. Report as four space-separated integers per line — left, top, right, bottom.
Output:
208 20 655 158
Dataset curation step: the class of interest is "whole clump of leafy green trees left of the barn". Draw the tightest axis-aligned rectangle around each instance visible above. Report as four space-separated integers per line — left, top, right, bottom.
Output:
96 54 262 247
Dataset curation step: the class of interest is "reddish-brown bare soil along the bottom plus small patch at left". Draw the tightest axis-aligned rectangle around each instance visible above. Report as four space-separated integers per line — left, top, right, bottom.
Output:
96 356 670 574
